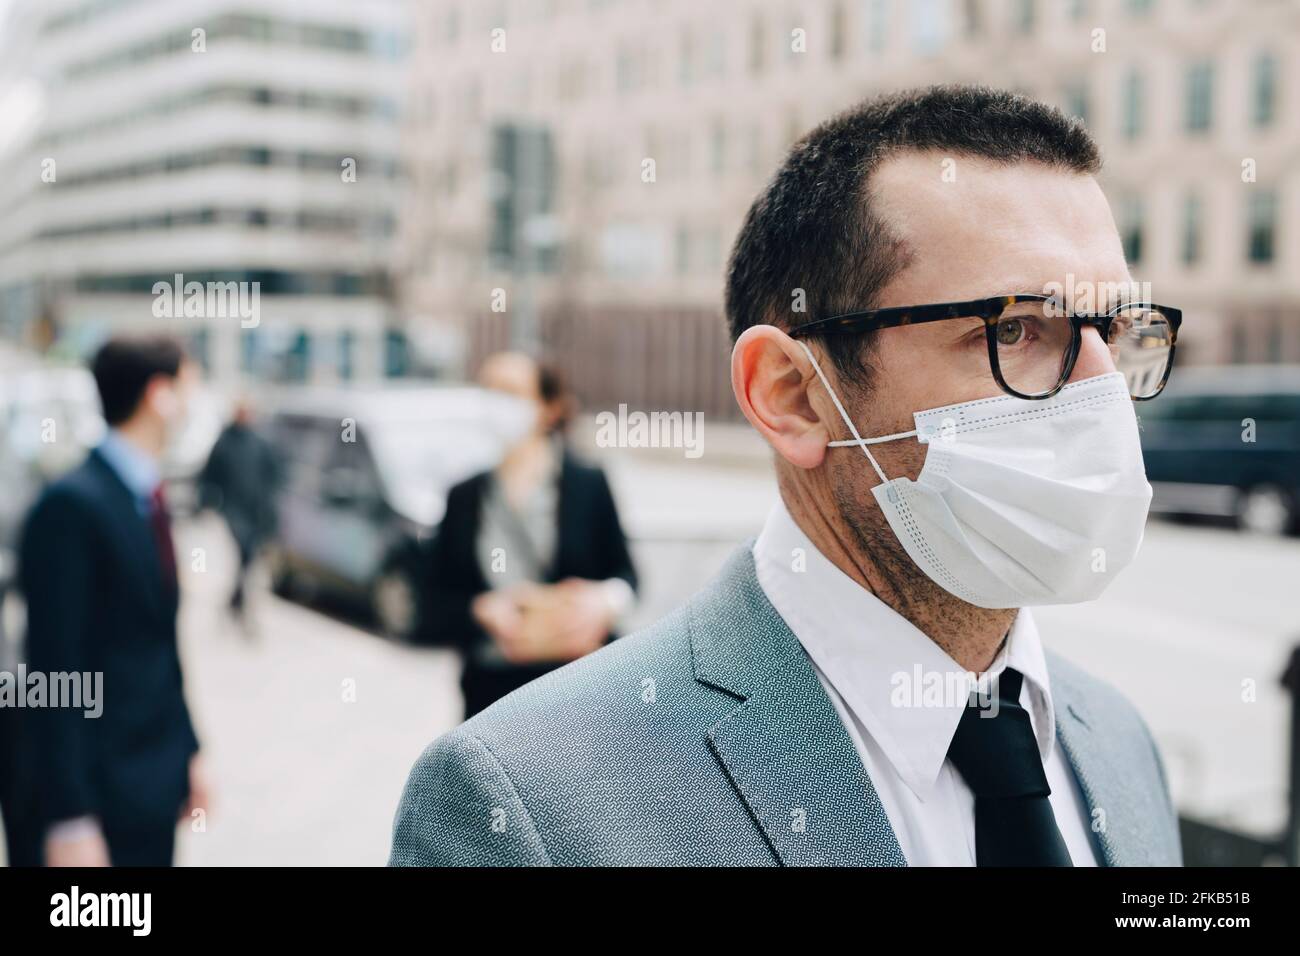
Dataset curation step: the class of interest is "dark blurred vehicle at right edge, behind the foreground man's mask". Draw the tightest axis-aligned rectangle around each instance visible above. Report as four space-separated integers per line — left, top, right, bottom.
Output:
1138 365 1300 535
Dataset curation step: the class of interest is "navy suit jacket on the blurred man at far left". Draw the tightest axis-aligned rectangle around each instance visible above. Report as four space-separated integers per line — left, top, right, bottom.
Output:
20 451 199 831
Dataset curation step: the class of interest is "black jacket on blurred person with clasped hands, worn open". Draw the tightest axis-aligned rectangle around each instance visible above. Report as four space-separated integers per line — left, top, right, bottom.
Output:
425 450 637 652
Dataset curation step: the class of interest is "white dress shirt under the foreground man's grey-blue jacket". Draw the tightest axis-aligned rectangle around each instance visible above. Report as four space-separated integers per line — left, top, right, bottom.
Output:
754 503 1097 866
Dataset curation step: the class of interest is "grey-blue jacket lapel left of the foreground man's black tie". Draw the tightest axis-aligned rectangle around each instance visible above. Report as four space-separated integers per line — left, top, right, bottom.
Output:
690 548 906 866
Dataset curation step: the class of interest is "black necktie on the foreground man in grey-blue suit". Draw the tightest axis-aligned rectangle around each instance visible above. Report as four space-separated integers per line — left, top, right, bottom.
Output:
948 667 1073 866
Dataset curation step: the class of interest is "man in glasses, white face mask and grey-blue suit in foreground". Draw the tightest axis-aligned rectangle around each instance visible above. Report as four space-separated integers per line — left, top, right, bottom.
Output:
393 87 1180 866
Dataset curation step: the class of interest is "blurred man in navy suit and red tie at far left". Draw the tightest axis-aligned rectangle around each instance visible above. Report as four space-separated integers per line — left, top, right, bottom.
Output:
20 337 207 866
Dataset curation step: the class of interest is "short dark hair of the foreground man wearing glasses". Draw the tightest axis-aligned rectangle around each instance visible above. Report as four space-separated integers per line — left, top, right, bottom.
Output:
727 86 1101 378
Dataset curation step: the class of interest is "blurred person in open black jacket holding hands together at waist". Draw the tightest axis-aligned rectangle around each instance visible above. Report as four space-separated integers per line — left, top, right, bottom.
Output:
426 352 637 717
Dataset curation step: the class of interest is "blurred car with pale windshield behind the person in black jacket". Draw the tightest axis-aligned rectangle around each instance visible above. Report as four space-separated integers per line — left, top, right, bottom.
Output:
264 385 508 640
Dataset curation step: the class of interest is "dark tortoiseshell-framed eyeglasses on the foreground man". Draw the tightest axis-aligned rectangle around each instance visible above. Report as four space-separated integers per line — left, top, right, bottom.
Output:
790 293 1183 402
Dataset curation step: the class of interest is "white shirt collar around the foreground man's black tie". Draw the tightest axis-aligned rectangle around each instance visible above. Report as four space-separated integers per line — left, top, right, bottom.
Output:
754 502 1056 800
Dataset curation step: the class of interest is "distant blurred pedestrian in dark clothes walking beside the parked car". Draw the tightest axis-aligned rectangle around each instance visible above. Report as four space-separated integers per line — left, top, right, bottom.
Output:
199 398 282 630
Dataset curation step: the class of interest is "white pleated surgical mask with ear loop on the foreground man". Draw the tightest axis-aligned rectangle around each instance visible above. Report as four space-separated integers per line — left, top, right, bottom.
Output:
800 342 1151 607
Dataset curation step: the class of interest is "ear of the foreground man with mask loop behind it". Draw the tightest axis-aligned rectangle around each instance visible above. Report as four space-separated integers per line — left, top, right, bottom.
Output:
732 325 831 468
